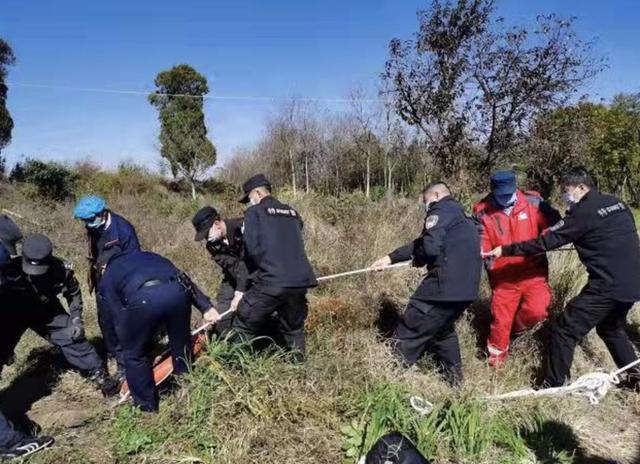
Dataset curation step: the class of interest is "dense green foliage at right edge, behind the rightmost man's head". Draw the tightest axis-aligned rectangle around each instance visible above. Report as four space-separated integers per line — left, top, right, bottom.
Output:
520 95 640 206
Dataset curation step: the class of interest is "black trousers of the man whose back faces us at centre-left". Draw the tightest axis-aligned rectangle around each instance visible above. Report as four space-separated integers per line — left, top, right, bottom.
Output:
232 284 308 361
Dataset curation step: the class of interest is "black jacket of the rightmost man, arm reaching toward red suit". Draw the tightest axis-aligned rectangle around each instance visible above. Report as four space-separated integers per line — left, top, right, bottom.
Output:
502 190 640 302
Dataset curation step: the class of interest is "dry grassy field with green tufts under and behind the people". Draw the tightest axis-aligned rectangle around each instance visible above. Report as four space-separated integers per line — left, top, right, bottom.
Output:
0 184 640 464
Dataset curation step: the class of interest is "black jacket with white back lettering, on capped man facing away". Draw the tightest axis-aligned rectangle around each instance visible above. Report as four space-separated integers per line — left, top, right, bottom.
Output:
244 196 317 288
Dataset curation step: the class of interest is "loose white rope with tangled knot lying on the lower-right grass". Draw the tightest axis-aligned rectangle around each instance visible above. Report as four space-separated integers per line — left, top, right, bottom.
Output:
409 359 640 416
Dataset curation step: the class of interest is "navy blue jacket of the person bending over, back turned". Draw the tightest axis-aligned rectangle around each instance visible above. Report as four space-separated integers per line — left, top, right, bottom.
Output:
98 251 212 313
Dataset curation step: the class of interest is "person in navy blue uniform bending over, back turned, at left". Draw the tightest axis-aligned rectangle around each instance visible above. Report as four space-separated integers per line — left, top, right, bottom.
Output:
98 251 218 412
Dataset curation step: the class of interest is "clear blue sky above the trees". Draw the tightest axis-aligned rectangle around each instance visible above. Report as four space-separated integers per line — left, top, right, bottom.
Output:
0 0 640 167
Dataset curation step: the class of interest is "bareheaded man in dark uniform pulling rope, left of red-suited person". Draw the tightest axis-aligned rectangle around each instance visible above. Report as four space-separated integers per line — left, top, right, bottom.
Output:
371 181 482 385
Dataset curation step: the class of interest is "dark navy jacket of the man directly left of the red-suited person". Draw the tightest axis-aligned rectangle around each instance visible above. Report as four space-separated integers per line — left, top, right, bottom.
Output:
389 196 482 302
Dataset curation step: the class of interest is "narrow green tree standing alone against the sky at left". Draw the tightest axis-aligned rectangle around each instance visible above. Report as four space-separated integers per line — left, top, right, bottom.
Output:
149 64 216 198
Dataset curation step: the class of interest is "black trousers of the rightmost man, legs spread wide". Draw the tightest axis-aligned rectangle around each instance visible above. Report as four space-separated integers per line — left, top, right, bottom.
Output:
545 284 637 387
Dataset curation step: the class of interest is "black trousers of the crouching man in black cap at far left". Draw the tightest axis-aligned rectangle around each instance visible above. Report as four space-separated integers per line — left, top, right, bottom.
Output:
0 298 104 374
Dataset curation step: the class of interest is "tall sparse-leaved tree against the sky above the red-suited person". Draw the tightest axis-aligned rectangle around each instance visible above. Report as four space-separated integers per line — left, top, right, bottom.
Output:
382 0 603 177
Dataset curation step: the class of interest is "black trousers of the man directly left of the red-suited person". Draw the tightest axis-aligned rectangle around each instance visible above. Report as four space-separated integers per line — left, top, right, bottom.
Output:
393 298 471 385
